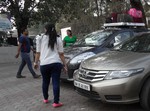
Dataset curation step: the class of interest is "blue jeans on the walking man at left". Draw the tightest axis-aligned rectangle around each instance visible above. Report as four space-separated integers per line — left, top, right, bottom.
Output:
17 53 36 76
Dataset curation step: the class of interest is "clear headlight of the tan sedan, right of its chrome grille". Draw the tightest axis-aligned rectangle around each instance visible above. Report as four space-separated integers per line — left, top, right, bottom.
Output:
105 68 144 80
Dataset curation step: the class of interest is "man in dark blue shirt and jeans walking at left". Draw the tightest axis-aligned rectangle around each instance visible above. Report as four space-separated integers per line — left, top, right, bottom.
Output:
16 29 41 78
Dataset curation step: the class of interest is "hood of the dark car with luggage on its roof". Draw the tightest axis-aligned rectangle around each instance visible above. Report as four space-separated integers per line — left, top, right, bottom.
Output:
64 46 94 59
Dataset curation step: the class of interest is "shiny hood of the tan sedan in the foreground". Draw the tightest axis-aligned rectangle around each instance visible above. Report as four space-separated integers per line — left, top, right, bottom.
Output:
82 51 150 70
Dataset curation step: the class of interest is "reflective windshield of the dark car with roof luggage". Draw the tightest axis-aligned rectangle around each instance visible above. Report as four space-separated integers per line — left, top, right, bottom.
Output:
75 30 113 46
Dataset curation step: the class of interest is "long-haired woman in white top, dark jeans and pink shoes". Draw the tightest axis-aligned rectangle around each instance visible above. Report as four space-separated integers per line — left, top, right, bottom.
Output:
34 24 67 107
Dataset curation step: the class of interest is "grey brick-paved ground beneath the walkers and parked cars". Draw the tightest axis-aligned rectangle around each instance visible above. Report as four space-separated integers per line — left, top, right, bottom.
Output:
0 63 144 111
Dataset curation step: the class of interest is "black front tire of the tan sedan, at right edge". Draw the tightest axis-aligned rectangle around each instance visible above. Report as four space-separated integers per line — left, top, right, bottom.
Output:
140 78 150 111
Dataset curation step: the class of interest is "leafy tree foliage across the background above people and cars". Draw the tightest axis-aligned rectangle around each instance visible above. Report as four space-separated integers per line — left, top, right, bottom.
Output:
0 0 149 36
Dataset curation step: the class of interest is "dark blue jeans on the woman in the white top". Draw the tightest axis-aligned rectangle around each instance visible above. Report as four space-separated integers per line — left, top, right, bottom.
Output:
40 63 62 103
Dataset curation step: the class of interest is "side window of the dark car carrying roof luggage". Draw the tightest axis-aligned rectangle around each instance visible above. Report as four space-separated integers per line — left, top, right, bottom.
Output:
113 32 131 46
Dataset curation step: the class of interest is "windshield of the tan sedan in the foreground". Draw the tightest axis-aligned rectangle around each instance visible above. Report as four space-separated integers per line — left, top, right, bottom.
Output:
119 34 150 53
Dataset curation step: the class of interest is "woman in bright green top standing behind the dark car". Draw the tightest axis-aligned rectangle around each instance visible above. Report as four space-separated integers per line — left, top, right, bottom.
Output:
64 30 77 47
